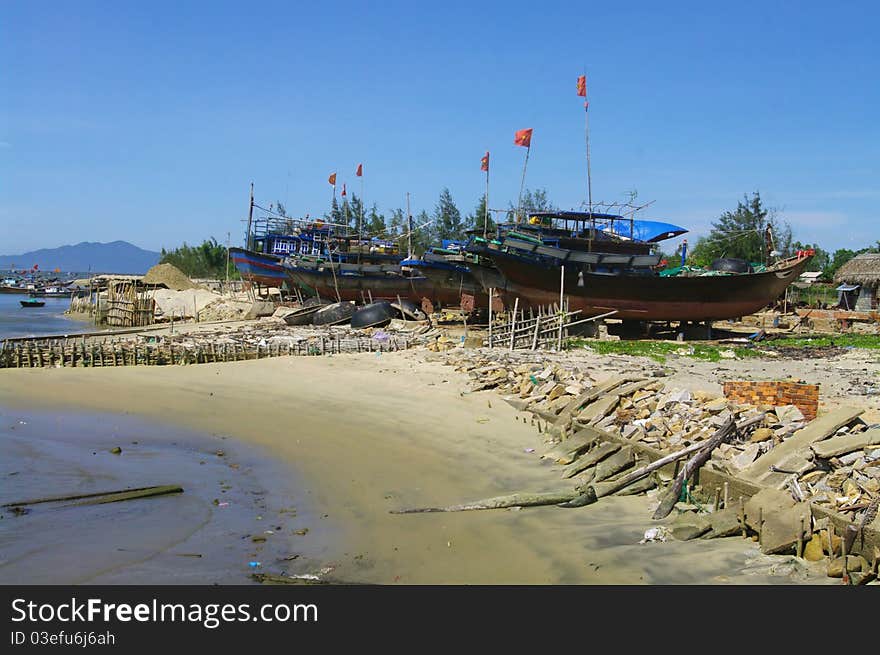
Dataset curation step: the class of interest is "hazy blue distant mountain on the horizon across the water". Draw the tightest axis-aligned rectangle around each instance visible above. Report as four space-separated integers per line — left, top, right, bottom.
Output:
0 241 161 274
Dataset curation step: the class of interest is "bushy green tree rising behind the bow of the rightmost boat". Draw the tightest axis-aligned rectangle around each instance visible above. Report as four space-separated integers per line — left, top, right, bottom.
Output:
688 191 792 266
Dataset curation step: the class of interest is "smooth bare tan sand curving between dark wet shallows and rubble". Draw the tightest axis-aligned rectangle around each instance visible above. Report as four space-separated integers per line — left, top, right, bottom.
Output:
0 351 835 584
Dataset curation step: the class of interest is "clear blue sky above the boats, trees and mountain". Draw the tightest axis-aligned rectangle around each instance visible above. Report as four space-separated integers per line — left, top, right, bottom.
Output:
0 0 880 254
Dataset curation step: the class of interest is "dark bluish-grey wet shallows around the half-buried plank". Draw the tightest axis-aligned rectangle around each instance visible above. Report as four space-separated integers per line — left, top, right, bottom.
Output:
0 407 332 584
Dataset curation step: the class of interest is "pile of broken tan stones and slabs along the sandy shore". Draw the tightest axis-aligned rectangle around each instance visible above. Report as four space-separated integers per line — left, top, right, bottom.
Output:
443 349 880 544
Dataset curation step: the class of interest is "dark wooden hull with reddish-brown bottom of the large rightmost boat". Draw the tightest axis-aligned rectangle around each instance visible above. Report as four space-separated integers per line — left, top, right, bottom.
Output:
491 250 812 321
